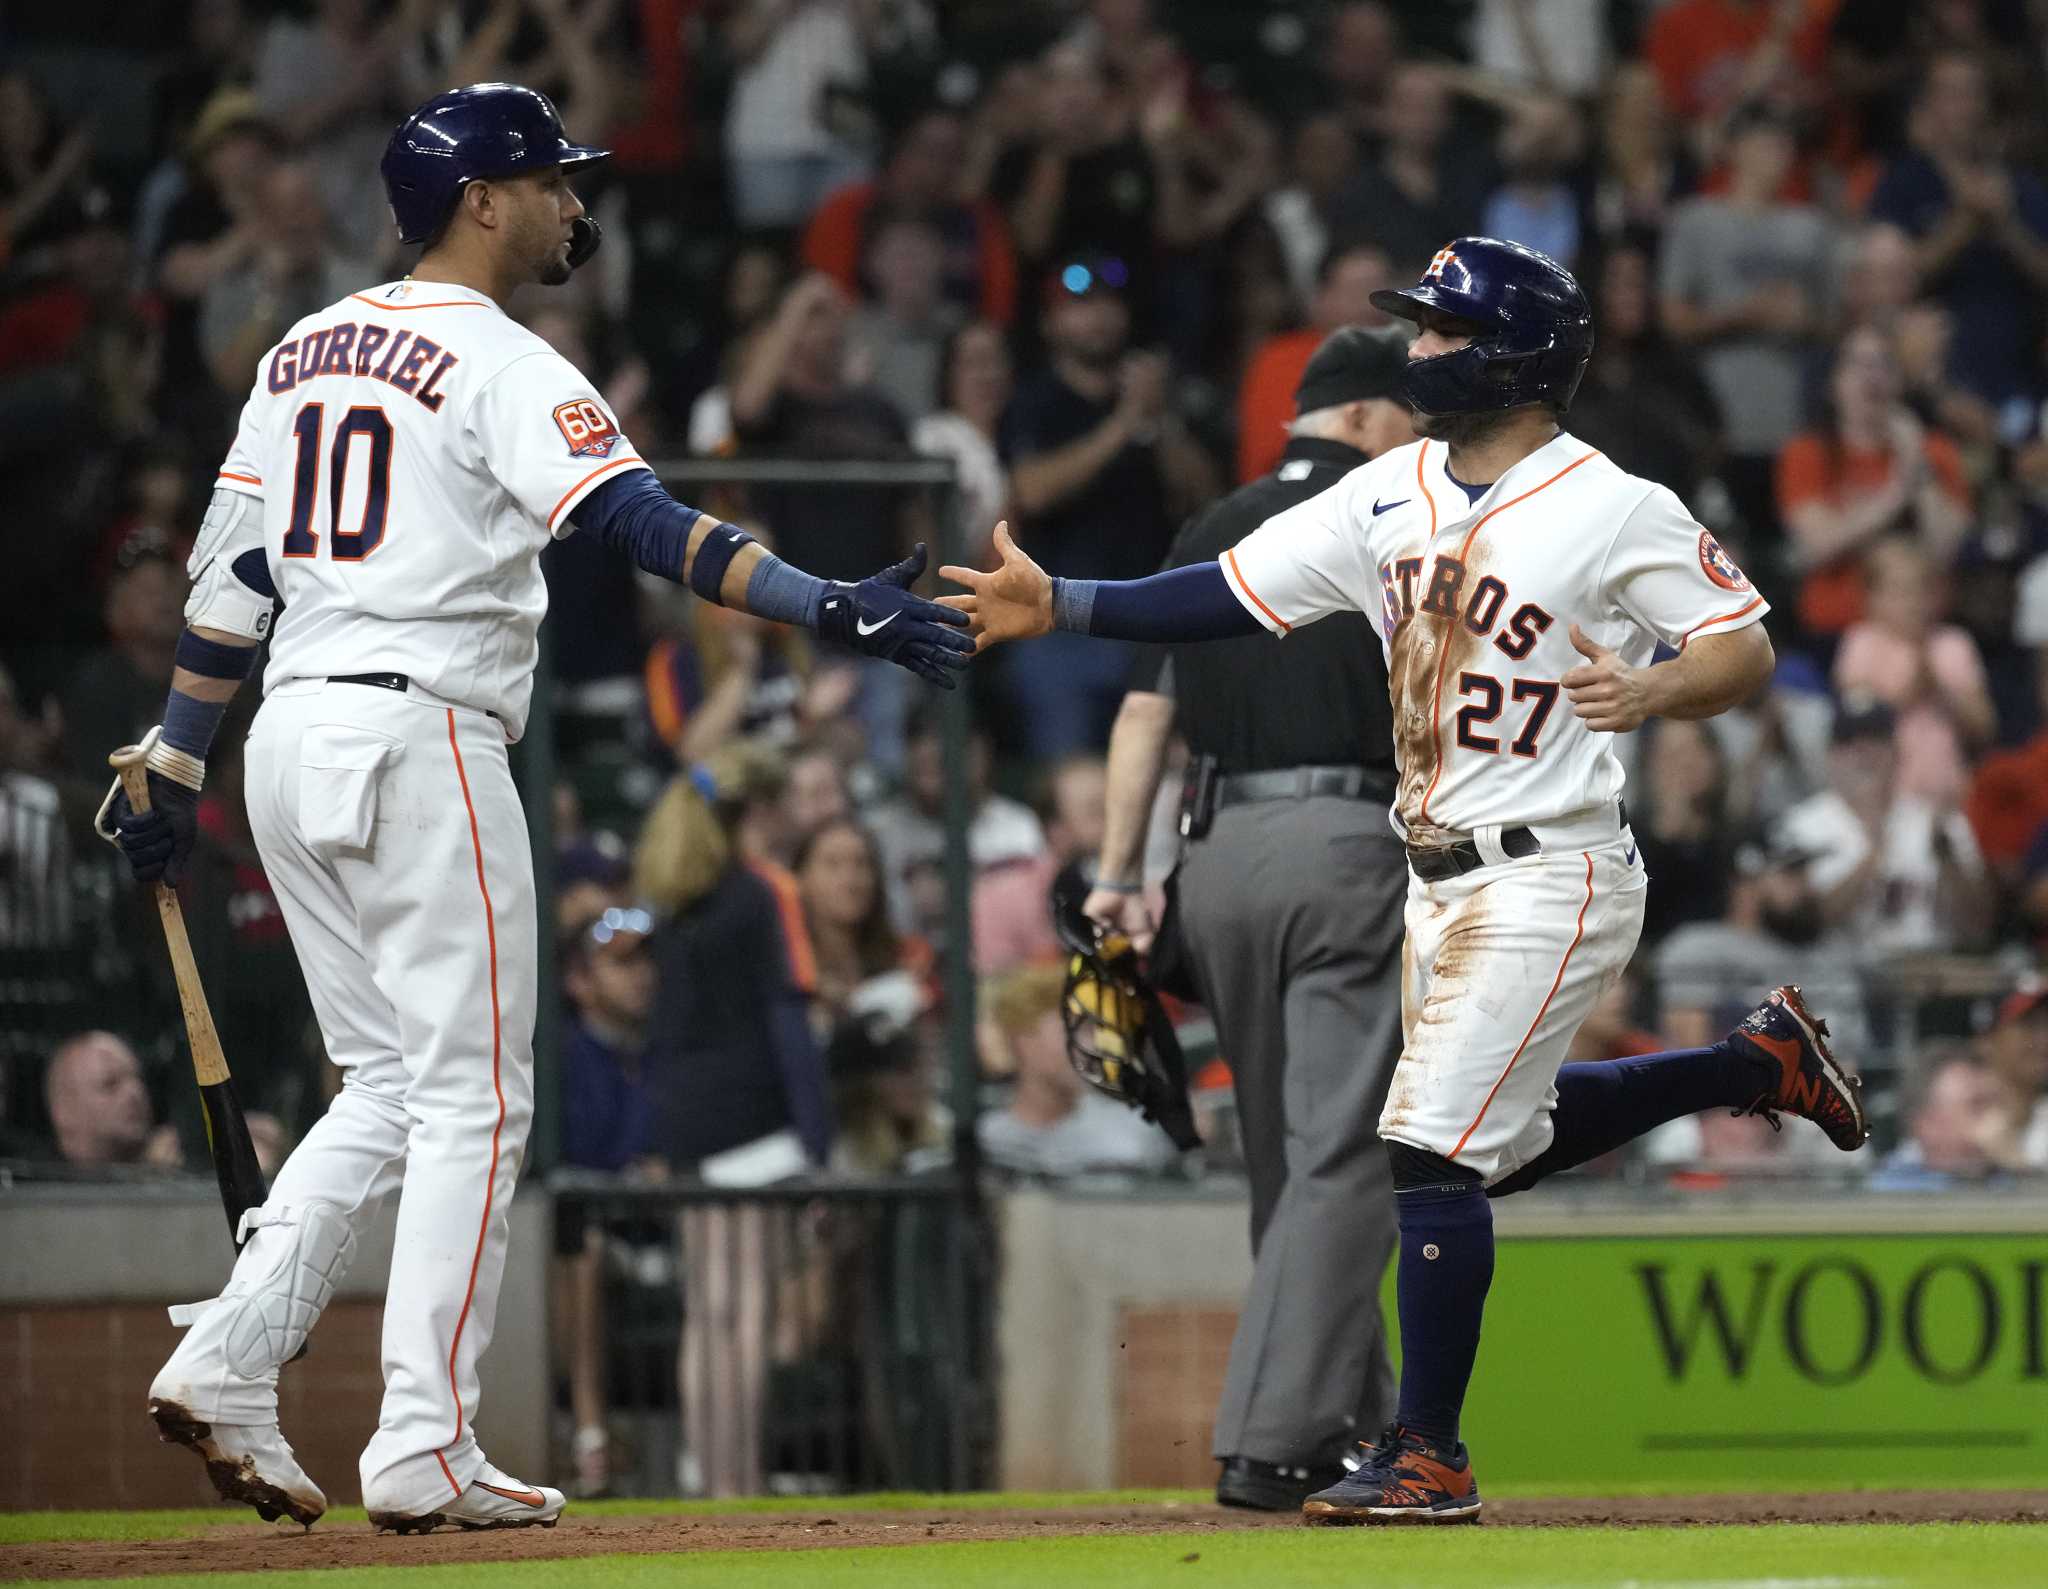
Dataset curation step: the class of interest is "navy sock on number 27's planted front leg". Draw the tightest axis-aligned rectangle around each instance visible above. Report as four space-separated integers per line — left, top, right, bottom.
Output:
1395 1182 1493 1452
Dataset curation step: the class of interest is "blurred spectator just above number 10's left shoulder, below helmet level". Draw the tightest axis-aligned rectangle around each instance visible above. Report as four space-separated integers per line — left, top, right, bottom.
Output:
199 160 377 397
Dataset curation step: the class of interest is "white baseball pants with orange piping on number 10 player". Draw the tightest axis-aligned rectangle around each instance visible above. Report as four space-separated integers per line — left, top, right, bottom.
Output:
158 680 535 1513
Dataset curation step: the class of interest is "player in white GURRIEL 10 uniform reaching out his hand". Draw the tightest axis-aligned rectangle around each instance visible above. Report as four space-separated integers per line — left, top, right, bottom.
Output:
111 84 973 1532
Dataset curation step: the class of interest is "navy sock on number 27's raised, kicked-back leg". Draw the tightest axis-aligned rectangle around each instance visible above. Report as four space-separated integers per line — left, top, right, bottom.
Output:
1489 1040 1776 1198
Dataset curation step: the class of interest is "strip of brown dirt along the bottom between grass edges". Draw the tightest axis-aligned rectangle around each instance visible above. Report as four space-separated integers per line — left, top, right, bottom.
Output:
0 1491 2048 1579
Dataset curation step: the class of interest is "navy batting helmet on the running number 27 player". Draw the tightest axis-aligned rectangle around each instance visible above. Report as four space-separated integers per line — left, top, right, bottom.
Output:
1372 238 1593 416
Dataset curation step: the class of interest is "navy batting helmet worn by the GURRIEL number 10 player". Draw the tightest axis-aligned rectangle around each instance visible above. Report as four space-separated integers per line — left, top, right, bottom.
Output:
381 82 612 249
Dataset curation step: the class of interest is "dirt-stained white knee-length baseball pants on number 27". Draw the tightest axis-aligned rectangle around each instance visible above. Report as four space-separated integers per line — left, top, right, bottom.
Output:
1380 819 1647 1186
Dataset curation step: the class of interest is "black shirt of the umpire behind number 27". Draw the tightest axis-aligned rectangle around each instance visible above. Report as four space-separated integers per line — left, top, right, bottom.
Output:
1133 436 1395 780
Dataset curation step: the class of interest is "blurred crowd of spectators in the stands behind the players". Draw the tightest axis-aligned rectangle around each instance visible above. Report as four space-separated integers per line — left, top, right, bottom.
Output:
0 0 2048 1212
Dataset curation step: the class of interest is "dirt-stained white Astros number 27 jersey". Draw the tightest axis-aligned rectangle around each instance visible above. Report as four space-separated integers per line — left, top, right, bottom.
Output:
1223 434 1769 835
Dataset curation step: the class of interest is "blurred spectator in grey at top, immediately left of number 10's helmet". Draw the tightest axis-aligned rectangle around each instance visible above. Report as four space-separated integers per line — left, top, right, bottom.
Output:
252 0 415 248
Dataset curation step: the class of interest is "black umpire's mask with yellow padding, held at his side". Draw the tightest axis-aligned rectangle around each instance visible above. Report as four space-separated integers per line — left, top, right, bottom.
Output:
1053 864 1202 1153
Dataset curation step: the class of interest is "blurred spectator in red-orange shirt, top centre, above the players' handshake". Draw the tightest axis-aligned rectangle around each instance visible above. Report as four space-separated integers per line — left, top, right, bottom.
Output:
803 104 1018 326
